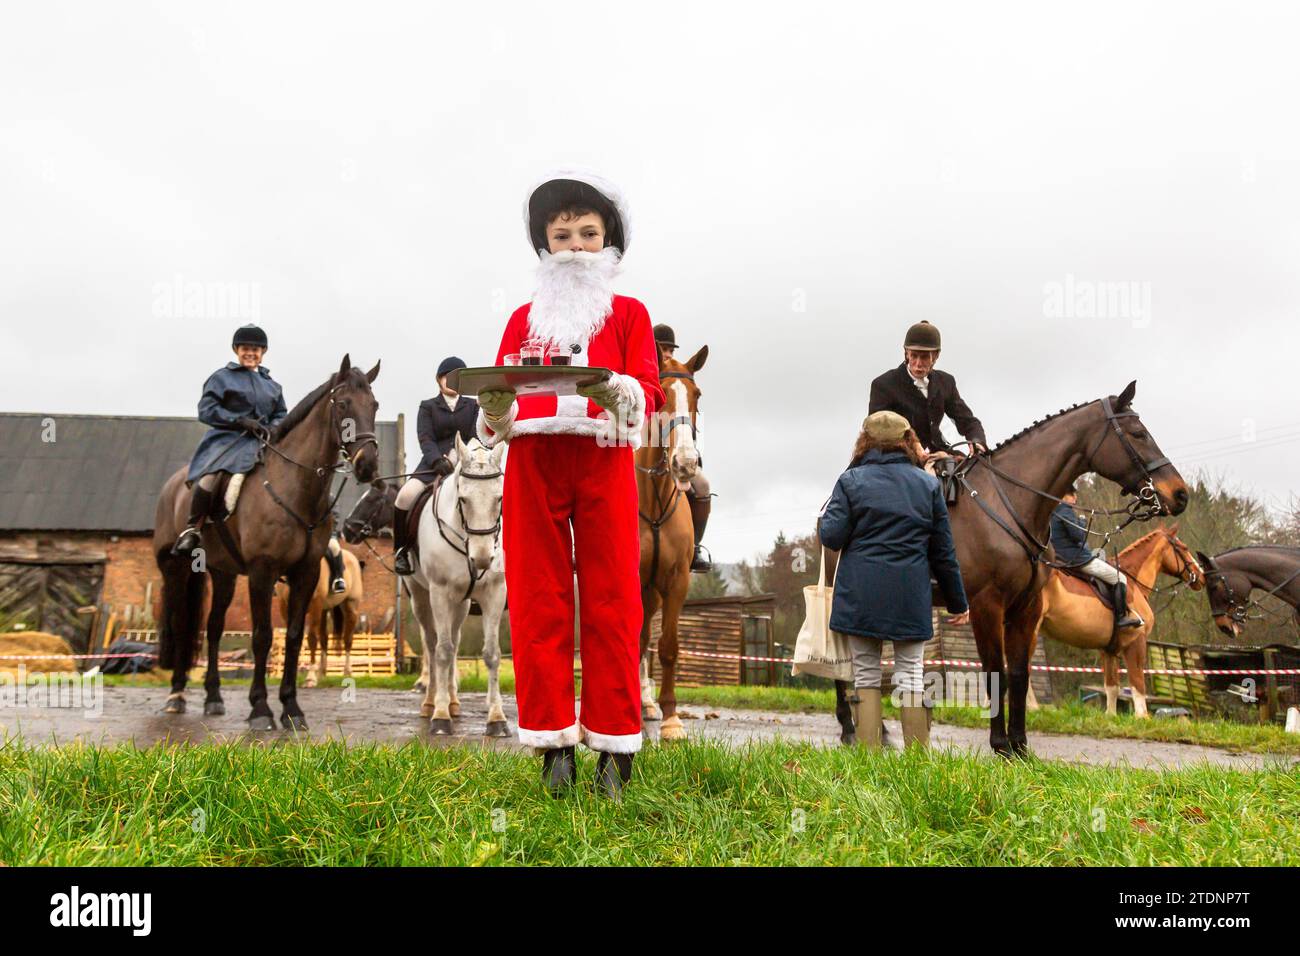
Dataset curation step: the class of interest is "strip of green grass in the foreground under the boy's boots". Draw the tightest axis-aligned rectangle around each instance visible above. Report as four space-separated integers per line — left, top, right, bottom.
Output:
0 743 1300 866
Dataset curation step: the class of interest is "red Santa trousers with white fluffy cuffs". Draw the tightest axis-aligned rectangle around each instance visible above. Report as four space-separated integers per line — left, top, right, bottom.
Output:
502 434 641 753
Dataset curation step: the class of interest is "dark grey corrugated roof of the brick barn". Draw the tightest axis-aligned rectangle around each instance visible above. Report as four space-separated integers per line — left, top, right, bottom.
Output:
0 412 403 533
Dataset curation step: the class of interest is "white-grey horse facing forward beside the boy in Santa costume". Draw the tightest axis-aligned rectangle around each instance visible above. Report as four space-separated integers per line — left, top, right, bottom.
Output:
403 434 510 737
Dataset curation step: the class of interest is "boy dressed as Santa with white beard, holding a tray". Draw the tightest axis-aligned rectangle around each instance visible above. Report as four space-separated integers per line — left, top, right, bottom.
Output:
478 170 663 797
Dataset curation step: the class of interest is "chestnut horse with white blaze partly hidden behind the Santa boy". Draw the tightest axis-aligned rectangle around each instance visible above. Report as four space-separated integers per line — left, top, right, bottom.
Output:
636 345 709 740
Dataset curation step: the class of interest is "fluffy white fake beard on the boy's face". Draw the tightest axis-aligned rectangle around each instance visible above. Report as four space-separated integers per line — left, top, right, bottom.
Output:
528 246 621 349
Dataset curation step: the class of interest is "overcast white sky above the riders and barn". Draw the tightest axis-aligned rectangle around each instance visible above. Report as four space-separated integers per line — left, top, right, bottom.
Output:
0 3 1300 561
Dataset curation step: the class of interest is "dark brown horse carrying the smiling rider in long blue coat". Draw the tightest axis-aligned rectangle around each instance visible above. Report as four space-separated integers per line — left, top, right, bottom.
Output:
153 355 380 731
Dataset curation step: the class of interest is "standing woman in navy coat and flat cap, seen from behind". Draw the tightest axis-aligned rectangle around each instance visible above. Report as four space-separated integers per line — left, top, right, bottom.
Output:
818 411 966 747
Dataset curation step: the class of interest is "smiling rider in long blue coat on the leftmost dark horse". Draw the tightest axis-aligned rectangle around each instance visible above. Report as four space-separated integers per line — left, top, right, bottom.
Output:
173 325 287 563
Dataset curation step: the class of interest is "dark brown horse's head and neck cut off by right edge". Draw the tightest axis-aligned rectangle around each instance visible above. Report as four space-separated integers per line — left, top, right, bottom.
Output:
1196 545 1300 637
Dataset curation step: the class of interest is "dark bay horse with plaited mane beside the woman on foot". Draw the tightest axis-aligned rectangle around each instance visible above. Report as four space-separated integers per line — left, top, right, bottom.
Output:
822 381 1190 756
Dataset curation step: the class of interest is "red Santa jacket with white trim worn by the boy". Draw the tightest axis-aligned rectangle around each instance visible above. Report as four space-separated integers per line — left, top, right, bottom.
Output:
478 295 663 447
